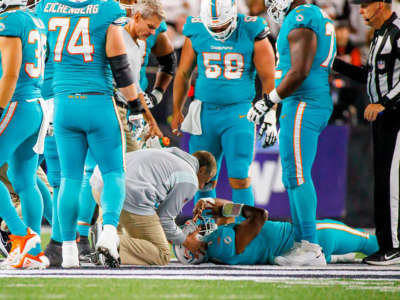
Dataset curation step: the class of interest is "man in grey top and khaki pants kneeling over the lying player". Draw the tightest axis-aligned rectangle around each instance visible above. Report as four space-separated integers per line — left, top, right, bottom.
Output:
90 148 217 267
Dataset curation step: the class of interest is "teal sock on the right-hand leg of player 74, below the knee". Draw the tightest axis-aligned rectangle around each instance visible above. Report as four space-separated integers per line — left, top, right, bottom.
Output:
101 172 125 227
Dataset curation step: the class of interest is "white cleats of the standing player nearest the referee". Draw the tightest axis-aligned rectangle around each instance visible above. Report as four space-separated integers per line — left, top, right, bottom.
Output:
275 240 326 266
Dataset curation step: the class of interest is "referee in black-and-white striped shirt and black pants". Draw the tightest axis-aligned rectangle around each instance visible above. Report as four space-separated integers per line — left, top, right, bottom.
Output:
333 0 400 265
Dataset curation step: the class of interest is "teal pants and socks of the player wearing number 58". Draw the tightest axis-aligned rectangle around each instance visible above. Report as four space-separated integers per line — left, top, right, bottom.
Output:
189 102 255 205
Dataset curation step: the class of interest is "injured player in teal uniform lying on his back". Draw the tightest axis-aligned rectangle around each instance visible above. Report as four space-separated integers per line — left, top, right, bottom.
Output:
174 198 378 265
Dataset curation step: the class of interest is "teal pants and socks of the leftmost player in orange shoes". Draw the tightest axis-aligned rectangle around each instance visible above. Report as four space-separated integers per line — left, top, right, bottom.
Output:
0 101 43 241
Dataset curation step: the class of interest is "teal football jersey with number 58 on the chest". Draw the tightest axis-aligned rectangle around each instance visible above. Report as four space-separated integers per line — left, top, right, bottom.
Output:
183 14 267 105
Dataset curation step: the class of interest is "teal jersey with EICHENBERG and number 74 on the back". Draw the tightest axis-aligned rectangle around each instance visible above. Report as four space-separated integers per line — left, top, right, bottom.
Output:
40 0 126 95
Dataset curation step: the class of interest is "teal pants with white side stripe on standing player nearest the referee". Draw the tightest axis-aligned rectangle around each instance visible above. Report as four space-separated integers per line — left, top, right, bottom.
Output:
279 99 331 243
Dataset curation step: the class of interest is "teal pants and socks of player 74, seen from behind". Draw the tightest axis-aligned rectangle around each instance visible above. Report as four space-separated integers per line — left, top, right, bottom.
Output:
54 94 125 241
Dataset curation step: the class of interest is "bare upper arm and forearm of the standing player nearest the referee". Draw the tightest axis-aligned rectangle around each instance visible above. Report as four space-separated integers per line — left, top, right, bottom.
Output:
276 28 317 99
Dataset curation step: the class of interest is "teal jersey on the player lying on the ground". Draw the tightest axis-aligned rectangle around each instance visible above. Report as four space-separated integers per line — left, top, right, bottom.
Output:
205 221 294 265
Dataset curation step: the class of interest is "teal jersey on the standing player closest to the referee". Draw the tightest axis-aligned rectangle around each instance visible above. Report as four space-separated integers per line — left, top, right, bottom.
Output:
275 4 336 108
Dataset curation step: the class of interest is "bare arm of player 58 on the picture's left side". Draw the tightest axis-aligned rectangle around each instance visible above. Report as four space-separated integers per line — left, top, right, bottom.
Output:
171 38 196 135
